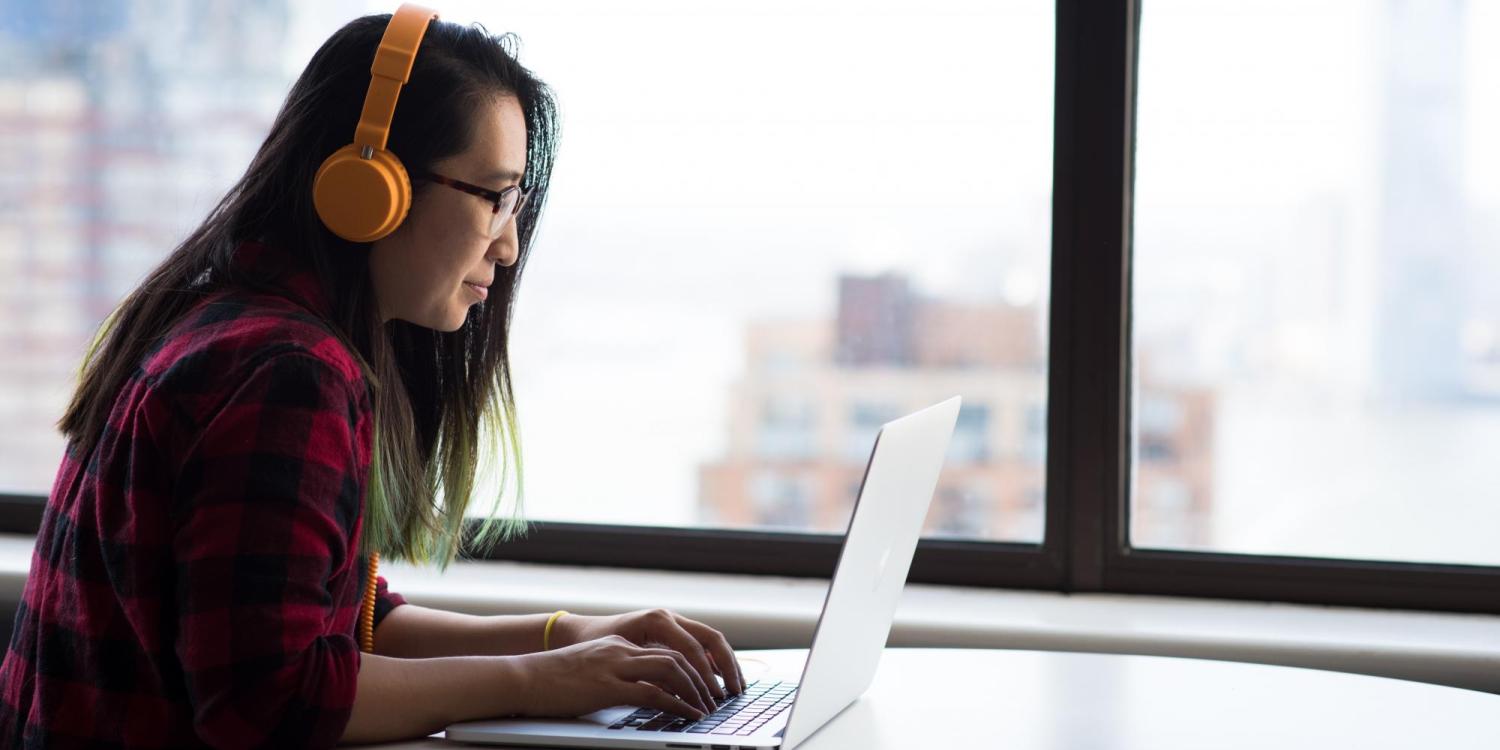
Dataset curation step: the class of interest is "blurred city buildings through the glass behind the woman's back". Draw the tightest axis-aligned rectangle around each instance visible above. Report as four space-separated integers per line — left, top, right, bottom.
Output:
0 0 288 494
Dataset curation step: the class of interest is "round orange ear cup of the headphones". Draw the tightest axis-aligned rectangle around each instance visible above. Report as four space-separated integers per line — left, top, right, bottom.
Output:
312 144 411 242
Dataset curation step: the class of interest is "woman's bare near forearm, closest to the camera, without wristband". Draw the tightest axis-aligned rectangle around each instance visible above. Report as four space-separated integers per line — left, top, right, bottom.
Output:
341 651 528 743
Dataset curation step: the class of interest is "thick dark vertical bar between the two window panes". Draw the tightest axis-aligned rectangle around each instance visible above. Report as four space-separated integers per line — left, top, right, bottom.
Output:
1047 0 1136 591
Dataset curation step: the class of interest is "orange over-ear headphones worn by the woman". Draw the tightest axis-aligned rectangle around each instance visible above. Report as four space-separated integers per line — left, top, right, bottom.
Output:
312 3 438 242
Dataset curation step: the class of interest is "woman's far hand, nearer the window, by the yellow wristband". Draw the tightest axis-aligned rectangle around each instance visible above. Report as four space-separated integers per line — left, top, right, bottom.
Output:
552 609 746 699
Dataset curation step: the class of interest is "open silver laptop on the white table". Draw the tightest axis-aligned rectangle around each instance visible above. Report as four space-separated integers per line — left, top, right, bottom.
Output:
447 396 960 750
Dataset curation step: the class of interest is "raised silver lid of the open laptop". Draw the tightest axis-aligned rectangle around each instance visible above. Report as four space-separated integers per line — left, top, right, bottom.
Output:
782 396 962 750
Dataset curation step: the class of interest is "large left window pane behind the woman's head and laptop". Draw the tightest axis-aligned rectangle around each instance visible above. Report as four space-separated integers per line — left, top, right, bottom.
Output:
0 0 1052 552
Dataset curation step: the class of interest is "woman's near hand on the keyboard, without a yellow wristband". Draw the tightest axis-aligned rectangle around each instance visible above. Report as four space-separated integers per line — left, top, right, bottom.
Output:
513 633 714 720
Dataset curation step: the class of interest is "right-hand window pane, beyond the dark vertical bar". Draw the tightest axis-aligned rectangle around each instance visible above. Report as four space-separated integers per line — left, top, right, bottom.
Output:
1131 0 1500 566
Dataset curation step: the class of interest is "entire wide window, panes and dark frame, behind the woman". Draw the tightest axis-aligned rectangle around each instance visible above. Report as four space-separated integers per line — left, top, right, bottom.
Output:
0 0 1500 612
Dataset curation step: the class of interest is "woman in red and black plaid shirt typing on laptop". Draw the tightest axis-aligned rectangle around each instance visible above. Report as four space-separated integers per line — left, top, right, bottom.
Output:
0 6 744 747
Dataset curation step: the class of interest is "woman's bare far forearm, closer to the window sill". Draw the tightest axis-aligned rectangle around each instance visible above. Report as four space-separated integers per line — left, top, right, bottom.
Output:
375 605 566 659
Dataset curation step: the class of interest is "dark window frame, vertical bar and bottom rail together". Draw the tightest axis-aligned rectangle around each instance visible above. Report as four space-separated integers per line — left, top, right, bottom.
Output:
0 0 1500 614
